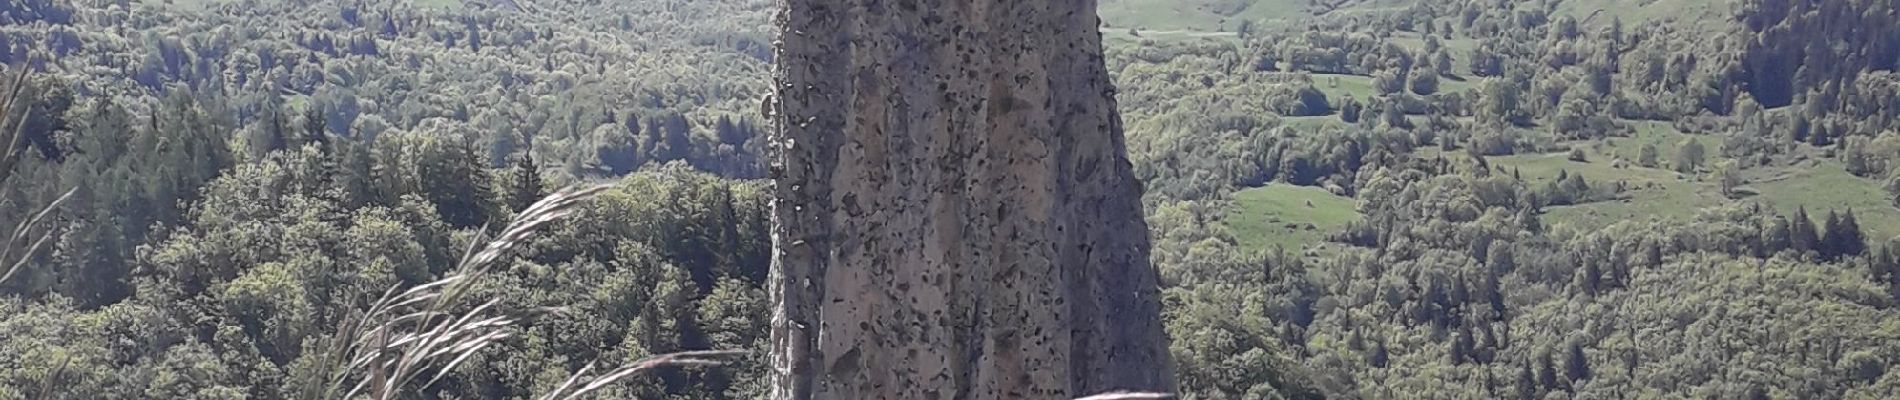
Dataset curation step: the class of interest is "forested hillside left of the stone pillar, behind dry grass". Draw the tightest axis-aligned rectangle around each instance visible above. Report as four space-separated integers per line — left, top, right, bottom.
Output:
0 0 775 398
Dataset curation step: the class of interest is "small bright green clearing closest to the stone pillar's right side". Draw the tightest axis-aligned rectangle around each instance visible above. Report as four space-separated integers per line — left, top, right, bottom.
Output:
1227 184 1359 250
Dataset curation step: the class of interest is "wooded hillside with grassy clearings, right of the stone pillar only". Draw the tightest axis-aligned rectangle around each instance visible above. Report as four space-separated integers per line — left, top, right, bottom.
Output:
1104 0 1900 398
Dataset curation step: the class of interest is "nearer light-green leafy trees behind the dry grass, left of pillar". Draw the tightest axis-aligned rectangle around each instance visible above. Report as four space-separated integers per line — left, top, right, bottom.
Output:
0 152 766 398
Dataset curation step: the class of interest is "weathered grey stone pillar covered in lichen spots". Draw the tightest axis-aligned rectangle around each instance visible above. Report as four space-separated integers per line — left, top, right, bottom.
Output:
768 0 1172 400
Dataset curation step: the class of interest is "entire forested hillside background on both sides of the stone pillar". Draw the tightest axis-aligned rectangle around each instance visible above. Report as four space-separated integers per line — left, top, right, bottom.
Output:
0 0 1900 398
